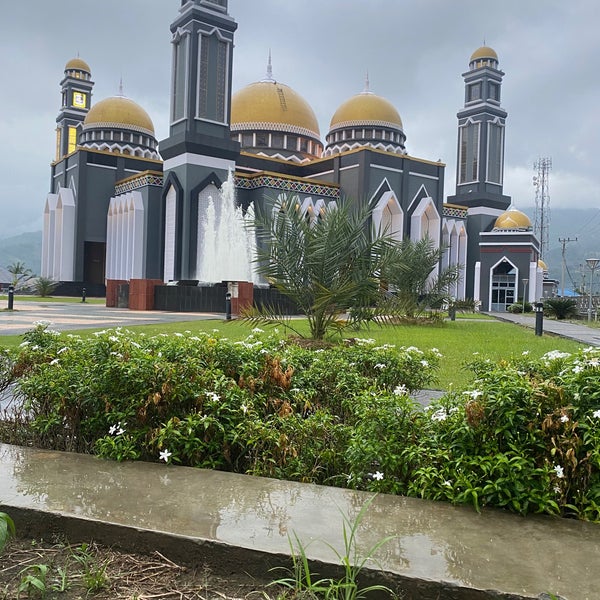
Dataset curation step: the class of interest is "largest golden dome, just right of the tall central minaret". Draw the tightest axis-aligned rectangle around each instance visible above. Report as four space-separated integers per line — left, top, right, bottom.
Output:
231 79 319 139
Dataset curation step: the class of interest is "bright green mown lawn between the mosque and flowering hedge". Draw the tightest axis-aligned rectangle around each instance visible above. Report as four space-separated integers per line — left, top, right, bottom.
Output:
0 315 582 390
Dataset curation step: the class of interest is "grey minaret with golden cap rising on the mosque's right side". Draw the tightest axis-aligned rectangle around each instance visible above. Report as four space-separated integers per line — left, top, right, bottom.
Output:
448 46 510 211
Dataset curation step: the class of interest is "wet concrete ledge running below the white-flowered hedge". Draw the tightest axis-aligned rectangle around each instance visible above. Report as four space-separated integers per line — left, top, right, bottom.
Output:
0 444 600 600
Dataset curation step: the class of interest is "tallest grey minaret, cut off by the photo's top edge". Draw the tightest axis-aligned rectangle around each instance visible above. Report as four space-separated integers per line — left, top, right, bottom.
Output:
159 0 240 280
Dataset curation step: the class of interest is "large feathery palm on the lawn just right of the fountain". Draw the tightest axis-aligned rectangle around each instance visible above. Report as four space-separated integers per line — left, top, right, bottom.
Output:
245 199 394 340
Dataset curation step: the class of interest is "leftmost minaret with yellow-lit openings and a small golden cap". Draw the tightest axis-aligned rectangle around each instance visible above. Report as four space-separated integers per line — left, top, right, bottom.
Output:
54 58 94 162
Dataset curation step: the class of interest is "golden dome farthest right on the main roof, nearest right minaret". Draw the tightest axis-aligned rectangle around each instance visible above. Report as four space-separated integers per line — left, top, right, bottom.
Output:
329 92 402 129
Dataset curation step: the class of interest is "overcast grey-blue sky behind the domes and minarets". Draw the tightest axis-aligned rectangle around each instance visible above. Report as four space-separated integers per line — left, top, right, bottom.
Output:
0 0 600 237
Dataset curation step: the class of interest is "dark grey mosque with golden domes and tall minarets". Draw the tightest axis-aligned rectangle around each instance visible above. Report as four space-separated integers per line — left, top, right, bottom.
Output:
42 0 545 311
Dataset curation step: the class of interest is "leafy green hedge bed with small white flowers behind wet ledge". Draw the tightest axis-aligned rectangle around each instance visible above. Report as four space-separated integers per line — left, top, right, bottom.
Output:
0 326 600 521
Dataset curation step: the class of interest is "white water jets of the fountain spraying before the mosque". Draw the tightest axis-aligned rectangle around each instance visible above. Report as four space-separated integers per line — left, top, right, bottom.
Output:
196 170 259 283
